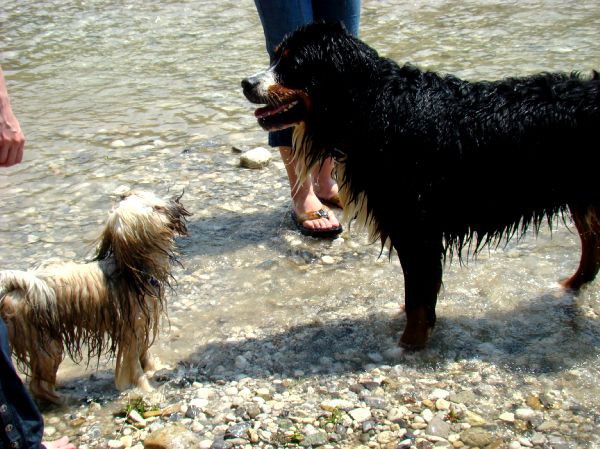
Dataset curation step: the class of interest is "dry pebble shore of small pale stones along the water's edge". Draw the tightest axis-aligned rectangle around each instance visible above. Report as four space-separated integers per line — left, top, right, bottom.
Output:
41 342 600 449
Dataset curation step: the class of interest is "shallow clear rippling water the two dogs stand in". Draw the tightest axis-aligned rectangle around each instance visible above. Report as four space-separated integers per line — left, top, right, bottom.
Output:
0 0 600 440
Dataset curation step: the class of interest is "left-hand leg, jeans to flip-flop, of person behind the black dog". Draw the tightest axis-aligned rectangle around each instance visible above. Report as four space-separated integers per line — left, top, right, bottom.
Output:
255 0 339 230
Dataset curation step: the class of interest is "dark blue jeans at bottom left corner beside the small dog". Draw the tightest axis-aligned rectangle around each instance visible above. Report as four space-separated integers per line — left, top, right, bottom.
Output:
0 318 44 449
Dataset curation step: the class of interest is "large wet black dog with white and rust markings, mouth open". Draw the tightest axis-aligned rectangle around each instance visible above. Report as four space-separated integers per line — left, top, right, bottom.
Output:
242 24 600 349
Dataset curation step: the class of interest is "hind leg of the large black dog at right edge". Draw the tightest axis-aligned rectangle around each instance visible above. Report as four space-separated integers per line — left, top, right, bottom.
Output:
562 204 600 290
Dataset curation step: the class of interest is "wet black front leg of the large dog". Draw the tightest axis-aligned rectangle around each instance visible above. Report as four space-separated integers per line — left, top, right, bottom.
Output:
394 234 443 349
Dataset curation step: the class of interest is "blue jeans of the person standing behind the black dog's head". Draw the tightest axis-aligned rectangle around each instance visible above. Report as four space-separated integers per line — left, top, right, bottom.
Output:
254 0 360 147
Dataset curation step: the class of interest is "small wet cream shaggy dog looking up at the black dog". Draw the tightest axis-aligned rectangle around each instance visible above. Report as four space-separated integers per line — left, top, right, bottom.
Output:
0 191 190 403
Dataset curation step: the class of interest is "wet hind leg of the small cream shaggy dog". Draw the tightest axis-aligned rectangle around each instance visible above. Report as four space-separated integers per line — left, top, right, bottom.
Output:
29 341 64 404
